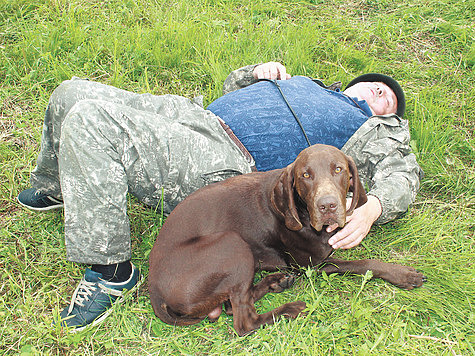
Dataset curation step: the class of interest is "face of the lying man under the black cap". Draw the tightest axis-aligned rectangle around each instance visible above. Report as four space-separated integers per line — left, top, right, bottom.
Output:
343 82 397 115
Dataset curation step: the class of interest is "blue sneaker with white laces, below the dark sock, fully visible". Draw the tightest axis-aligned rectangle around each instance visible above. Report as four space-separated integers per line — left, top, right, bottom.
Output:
59 264 141 332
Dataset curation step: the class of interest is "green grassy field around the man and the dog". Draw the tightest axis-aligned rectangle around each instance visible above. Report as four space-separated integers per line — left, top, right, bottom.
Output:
0 0 475 355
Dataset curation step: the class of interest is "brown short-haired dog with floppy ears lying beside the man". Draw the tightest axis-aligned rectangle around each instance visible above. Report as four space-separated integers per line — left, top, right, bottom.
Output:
149 145 425 335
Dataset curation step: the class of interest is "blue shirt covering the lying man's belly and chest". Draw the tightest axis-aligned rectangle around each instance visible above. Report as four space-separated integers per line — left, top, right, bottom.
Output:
207 76 372 171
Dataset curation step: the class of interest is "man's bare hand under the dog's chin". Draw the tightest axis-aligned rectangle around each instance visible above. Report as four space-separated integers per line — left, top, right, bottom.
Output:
327 195 382 249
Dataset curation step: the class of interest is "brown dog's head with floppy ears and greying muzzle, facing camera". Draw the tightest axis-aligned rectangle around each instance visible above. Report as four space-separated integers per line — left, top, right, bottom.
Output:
271 145 367 231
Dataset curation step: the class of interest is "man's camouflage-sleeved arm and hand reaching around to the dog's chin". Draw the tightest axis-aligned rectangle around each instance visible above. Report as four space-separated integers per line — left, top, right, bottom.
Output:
328 115 423 249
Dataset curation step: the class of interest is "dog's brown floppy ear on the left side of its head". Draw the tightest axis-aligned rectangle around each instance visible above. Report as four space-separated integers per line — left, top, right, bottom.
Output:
271 164 303 231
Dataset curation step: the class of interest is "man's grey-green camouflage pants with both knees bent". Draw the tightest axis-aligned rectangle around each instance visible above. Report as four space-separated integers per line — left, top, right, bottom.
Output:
31 78 252 264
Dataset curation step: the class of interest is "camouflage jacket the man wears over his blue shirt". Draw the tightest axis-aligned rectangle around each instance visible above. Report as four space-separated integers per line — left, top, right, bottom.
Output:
223 65 423 224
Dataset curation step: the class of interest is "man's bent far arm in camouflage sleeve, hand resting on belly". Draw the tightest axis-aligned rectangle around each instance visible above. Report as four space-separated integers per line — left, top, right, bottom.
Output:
223 62 291 94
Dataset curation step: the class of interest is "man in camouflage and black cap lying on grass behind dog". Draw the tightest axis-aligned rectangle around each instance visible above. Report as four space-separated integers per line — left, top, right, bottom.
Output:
18 62 421 330
